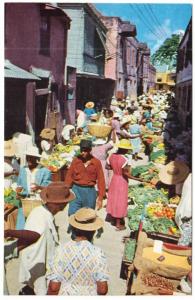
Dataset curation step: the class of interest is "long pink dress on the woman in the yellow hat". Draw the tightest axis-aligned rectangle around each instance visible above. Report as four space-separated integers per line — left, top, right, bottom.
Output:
106 154 128 218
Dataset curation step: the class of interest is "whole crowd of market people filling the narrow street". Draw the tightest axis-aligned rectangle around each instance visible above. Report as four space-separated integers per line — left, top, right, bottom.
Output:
4 91 191 295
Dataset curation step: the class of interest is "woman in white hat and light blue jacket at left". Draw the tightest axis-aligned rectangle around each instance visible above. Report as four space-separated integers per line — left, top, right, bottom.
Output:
16 146 51 229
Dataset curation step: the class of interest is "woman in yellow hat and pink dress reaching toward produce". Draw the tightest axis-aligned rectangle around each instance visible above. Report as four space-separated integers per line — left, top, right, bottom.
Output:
106 139 143 231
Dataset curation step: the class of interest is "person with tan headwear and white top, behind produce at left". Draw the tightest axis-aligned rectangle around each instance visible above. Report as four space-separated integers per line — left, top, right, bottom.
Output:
40 128 55 159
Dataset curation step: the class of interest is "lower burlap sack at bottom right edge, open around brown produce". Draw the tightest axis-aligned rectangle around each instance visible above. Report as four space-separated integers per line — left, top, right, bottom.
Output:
131 271 180 295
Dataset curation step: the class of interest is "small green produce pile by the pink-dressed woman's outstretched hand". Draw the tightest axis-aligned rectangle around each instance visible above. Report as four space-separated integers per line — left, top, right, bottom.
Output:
131 162 159 182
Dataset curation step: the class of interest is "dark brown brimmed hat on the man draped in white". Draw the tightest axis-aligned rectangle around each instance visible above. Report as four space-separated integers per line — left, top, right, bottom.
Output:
40 181 75 203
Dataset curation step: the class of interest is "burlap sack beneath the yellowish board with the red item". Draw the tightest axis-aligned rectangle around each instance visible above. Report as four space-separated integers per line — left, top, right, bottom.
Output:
133 232 192 279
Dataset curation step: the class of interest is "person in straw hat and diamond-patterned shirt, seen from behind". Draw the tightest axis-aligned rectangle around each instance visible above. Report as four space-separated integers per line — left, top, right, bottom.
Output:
47 207 109 296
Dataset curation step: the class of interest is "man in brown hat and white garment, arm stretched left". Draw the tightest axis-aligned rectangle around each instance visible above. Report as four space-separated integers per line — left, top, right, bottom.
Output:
5 181 75 295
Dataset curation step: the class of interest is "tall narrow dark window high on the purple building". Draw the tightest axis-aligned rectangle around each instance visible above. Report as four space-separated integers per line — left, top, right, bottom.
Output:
40 16 50 56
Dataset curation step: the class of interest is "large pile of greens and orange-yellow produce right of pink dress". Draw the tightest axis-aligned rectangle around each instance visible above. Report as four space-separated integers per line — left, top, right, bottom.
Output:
128 186 179 236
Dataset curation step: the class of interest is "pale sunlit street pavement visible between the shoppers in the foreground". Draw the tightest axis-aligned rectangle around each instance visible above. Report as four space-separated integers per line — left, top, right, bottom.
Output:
6 154 147 296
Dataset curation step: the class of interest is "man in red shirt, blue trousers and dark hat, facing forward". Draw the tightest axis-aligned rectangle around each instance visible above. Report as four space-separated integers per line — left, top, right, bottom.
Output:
65 140 105 216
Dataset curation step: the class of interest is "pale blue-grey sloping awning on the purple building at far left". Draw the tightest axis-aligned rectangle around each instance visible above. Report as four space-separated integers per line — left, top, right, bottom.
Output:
4 59 41 80
